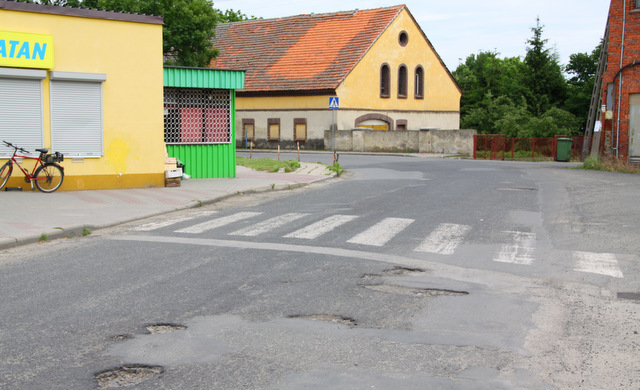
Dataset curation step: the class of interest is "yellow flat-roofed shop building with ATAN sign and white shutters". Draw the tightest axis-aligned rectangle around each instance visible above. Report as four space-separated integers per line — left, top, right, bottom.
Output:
0 0 165 190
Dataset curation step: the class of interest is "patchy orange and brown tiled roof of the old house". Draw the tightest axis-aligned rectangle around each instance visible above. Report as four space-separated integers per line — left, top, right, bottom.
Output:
212 5 404 92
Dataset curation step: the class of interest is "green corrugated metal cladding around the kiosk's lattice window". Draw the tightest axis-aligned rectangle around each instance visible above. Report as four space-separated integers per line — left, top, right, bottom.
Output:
164 67 244 179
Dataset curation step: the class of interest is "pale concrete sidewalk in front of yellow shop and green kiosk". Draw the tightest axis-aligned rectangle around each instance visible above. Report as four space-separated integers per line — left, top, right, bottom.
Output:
0 163 335 249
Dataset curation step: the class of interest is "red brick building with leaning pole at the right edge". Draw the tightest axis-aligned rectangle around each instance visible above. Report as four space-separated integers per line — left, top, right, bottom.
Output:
594 0 640 163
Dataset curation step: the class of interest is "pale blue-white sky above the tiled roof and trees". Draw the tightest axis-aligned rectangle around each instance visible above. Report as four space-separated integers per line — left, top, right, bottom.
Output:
214 0 610 72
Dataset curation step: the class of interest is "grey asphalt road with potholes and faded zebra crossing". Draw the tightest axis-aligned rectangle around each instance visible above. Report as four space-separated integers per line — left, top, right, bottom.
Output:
0 154 640 389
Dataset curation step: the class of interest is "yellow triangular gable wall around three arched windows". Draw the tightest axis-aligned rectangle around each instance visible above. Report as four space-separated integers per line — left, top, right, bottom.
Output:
338 9 461 111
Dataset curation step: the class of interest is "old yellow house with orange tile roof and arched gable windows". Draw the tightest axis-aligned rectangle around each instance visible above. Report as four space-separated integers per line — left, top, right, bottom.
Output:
211 5 461 149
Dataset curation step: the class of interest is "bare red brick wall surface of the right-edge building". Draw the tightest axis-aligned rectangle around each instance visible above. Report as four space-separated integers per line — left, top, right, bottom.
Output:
601 0 640 158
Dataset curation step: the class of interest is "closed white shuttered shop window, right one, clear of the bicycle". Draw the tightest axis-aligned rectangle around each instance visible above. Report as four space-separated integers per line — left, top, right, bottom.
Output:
50 71 107 157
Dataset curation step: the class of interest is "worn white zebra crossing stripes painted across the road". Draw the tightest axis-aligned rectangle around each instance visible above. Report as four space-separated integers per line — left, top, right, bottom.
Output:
132 211 624 278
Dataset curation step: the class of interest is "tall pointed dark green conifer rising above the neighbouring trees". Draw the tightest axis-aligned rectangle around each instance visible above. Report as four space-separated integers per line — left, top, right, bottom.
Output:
523 18 567 116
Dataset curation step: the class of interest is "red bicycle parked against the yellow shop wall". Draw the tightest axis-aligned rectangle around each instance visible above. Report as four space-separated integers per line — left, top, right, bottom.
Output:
0 140 64 193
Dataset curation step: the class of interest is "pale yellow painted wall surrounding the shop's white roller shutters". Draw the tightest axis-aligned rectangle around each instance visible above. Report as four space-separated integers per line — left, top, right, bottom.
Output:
0 10 165 190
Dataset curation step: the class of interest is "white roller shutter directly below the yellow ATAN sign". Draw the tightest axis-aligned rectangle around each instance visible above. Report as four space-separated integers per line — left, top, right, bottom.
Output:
0 72 44 158
